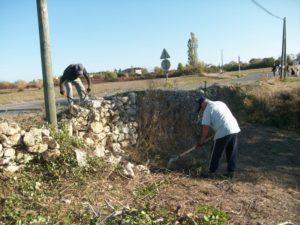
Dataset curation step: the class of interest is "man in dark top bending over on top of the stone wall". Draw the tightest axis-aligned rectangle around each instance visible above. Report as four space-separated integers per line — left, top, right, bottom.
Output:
59 64 91 105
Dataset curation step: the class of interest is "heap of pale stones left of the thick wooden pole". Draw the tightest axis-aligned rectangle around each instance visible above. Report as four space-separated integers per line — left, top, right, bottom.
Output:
0 122 60 172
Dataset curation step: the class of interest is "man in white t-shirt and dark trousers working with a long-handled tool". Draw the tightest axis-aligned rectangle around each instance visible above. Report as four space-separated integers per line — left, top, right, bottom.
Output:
197 97 241 177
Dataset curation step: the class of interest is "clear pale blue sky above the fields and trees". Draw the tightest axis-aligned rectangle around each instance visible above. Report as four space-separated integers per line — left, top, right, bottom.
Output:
0 0 300 82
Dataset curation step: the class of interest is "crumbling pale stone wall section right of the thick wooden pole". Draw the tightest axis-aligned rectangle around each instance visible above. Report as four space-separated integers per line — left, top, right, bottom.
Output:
61 92 149 177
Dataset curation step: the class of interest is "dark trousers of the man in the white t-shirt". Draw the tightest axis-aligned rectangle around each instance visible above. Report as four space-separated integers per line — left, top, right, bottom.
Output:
209 134 238 173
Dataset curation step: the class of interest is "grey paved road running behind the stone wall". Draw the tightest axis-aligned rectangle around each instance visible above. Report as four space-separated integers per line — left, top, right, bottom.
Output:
0 74 267 113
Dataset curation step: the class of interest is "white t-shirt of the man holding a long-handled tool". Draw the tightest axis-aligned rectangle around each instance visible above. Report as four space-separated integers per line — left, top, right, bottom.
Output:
202 100 241 140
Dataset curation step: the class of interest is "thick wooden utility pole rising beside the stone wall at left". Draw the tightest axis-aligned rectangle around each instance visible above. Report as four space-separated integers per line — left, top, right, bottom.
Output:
36 0 57 127
